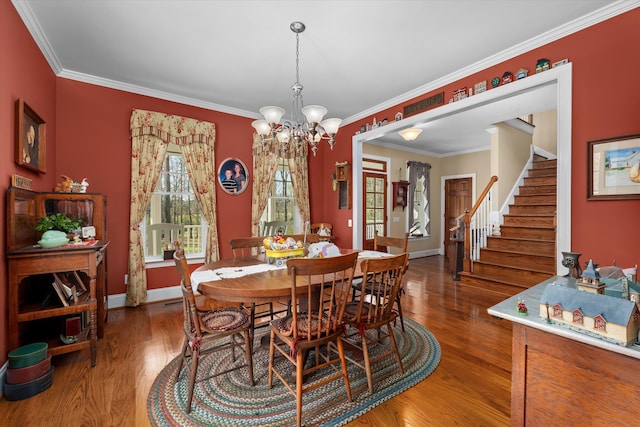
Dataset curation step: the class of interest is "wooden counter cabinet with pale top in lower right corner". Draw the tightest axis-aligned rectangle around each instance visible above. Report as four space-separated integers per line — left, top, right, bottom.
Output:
488 278 640 426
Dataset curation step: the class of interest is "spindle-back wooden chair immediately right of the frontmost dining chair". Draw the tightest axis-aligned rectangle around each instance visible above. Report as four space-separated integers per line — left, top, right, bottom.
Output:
343 253 409 393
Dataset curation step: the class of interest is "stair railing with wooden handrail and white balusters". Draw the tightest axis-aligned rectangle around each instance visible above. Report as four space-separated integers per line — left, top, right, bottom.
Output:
462 175 498 273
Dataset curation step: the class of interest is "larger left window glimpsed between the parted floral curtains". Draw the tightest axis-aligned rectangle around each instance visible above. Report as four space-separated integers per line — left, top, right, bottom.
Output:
142 146 207 262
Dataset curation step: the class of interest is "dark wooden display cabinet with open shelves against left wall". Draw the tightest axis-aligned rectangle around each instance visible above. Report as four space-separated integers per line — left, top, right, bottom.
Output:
7 187 109 366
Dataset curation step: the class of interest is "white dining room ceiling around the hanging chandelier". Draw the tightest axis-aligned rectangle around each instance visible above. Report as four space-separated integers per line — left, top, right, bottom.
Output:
12 0 638 154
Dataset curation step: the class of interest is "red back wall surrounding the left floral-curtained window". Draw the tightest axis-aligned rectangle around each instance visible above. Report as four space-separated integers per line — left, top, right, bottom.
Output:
56 79 320 294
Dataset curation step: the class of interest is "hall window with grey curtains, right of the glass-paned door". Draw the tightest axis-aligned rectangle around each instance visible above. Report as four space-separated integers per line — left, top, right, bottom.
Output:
407 161 431 237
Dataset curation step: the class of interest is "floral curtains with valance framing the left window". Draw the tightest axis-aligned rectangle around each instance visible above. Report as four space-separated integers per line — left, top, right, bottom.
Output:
125 110 218 307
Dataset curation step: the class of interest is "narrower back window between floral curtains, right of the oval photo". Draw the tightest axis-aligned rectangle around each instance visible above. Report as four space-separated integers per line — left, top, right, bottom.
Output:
260 158 302 234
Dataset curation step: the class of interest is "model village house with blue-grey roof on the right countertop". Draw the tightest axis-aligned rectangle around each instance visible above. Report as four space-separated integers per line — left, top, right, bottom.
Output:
536 260 640 346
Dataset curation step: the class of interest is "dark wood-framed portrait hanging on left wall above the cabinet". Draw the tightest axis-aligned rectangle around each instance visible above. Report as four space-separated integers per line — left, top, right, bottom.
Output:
15 99 47 173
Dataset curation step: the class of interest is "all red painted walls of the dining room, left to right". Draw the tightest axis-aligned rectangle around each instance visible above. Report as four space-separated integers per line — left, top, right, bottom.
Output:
0 1 640 363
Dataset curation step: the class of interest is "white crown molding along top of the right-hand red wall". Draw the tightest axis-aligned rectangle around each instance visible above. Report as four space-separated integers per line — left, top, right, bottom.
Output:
341 0 640 127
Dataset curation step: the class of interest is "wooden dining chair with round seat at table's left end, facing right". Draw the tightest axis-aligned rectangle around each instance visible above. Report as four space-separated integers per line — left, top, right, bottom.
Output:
173 242 255 413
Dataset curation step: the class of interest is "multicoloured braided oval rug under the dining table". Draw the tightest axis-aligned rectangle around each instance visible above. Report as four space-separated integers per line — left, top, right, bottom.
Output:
147 318 441 427
